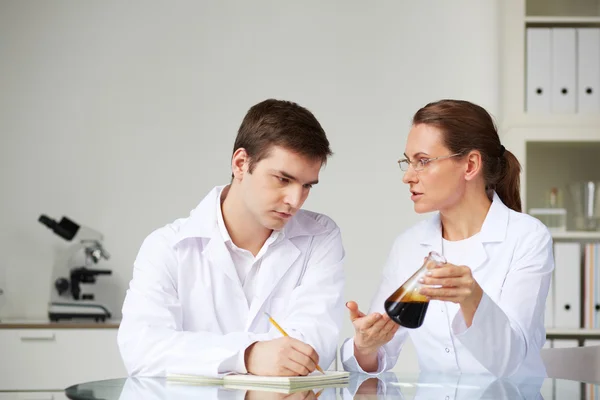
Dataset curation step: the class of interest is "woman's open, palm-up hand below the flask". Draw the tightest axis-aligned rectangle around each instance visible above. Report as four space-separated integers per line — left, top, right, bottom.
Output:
346 301 400 354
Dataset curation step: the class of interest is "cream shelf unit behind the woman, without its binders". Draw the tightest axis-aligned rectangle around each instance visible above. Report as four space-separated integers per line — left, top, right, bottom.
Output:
497 0 600 345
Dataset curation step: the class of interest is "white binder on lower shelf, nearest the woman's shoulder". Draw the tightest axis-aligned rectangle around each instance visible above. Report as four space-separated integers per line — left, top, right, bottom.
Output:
554 242 581 328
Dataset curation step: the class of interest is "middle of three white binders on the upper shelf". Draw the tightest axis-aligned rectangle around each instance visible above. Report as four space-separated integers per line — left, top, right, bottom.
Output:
550 28 577 114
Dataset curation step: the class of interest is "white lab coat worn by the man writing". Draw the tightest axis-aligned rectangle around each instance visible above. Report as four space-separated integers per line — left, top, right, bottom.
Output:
118 187 344 376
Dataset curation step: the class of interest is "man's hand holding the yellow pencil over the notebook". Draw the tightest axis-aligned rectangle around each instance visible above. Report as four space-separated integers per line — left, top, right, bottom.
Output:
244 337 319 376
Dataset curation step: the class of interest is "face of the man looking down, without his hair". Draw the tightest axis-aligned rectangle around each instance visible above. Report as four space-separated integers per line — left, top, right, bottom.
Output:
240 146 321 230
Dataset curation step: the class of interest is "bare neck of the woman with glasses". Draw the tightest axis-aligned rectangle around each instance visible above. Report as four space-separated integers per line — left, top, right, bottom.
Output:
440 190 492 241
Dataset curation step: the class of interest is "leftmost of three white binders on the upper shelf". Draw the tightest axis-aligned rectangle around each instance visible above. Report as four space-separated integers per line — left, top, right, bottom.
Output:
525 28 552 113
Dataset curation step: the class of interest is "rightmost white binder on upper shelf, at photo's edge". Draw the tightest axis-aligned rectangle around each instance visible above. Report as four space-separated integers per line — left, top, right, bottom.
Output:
577 28 600 114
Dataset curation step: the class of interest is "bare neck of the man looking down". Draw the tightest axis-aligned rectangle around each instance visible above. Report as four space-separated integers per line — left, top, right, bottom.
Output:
220 185 272 256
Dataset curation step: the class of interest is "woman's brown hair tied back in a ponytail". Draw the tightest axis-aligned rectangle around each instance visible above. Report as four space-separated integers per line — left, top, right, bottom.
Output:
413 100 521 212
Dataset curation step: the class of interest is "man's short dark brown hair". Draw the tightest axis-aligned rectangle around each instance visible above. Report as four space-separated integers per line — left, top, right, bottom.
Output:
233 99 333 173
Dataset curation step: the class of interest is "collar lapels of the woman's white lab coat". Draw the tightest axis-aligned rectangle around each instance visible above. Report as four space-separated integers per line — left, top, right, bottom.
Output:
420 192 510 270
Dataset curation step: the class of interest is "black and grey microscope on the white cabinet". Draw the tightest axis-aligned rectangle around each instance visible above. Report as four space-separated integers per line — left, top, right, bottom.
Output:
38 214 112 322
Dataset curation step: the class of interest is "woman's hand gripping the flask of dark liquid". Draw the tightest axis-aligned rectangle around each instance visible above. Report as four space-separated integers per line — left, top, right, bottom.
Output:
419 263 483 327
